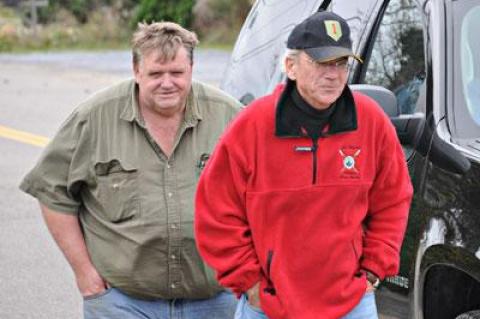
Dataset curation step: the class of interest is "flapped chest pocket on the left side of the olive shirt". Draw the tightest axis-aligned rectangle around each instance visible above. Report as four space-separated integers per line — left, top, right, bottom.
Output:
95 159 141 223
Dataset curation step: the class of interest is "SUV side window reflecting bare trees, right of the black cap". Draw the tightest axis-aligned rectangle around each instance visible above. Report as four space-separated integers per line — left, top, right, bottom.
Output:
362 0 425 114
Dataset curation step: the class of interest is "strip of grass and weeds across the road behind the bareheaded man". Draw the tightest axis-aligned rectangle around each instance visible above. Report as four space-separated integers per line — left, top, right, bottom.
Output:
0 5 236 53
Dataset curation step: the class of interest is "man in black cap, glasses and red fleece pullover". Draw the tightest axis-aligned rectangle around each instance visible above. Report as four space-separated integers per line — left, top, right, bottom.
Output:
195 12 412 319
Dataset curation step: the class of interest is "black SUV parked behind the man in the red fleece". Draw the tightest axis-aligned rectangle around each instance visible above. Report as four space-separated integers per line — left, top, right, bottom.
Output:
222 0 480 319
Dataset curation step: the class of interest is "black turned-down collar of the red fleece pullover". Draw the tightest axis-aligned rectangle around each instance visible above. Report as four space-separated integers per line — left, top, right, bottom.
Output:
275 80 357 137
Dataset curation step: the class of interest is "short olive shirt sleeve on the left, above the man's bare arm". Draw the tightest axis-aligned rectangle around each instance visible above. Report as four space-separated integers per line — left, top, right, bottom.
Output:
20 111 91 214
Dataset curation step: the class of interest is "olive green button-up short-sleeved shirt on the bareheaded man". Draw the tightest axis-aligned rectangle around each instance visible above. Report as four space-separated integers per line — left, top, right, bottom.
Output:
20 80 240 299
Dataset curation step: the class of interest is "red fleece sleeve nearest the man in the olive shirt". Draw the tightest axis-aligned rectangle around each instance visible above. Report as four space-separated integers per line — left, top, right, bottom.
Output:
195 129 261 295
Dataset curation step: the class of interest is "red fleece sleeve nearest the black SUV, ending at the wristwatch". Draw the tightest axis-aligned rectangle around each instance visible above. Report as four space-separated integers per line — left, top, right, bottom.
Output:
361 116 413 279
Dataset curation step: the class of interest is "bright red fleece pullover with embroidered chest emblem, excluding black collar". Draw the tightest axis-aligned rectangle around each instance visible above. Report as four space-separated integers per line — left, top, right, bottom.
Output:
195 87 412 319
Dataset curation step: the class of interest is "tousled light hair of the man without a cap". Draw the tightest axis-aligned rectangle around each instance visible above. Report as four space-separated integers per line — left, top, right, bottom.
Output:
132 22 198 65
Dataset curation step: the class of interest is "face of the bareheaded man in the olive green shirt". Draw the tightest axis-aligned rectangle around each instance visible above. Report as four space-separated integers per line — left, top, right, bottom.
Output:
134 47 192 115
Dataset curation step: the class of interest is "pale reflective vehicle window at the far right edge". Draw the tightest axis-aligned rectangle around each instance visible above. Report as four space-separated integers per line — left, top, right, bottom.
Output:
452 1 480 138
